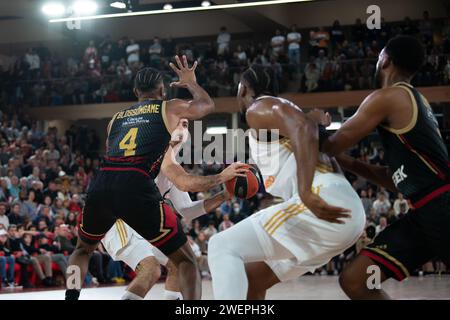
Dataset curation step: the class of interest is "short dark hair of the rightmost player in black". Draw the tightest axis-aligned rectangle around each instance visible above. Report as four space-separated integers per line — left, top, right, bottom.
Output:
384 35 425 76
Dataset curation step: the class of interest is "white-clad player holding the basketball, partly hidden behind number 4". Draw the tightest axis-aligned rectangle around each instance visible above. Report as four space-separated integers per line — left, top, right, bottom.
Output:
102 119 239 300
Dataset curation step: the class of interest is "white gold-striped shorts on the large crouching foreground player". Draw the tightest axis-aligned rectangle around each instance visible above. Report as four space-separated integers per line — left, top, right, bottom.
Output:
249 173 366 281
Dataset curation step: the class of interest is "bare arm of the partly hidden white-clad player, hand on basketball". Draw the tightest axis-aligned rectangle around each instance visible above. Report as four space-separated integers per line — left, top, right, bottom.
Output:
161 147 248 192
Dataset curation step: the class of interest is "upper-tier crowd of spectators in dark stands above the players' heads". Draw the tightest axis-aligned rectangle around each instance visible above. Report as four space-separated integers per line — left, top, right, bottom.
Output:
0 12 450 106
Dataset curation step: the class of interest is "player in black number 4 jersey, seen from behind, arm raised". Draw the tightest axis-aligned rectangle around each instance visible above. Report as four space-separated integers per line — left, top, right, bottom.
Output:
66 56 245 300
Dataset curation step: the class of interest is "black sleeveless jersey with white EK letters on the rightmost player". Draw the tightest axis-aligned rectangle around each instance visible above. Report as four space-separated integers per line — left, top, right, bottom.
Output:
378 82 450 201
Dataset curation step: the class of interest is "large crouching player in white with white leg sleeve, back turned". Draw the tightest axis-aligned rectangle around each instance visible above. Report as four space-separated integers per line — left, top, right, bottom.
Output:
208 65 365 299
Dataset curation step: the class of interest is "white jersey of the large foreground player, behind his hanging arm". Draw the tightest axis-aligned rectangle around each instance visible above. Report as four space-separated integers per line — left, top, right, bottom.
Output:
249 134 333 200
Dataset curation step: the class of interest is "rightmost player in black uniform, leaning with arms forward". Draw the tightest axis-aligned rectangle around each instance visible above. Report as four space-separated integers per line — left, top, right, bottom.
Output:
312 36 450 299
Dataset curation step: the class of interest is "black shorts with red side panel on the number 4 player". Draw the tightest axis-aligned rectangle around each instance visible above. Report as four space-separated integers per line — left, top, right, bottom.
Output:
79 171 187 255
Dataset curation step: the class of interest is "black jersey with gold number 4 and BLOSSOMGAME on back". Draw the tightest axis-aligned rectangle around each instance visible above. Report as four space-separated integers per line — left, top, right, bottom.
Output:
105 100 170 178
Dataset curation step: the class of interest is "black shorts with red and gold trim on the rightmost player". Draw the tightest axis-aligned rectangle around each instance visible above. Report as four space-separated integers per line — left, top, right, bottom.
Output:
360 191 450 281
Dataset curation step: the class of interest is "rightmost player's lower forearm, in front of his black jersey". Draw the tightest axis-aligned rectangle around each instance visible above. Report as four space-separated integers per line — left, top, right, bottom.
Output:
336 154 398 192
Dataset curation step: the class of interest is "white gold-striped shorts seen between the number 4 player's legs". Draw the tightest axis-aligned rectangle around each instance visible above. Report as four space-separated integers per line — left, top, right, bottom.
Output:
102 219 169 270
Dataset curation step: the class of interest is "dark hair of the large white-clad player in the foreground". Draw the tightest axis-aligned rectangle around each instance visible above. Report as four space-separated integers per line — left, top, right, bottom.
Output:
242 64 277 98
